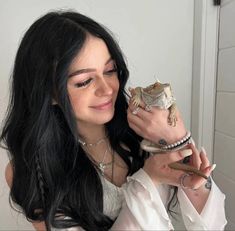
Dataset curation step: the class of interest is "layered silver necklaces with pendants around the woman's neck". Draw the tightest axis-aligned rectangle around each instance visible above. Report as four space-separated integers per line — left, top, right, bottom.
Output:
78 137 114 177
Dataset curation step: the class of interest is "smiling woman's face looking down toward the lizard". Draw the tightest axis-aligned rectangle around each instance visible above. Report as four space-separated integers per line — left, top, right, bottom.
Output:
67 36 119 125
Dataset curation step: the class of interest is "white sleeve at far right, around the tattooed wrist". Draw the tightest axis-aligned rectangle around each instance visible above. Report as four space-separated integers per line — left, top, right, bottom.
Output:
177 180 227 230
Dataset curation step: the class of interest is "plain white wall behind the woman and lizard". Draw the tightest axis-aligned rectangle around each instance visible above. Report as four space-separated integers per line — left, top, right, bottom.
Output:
0 0 194 230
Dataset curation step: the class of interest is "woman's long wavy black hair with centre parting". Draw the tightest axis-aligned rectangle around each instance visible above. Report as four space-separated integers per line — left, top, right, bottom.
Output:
0 11 176 230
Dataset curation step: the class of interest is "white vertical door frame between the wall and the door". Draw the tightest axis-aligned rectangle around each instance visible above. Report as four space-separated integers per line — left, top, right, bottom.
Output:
191 0 220 161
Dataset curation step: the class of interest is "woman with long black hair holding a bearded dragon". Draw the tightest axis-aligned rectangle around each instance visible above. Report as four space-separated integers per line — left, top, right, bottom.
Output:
1 12 226 230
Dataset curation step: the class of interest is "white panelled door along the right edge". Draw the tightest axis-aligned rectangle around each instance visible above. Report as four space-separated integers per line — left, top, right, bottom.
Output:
214 0 235 230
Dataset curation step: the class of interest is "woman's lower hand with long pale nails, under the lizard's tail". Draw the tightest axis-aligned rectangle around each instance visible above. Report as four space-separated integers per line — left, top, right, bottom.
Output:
143 144 214 190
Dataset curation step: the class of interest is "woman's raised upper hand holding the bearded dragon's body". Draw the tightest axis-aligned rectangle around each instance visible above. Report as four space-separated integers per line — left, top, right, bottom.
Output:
127 98 186 143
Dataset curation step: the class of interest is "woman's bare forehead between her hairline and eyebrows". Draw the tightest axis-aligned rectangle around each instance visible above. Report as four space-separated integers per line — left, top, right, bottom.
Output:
70 35 110 71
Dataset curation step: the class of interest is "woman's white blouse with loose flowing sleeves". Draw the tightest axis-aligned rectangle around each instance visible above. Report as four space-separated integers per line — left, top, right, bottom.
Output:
56 169 227 231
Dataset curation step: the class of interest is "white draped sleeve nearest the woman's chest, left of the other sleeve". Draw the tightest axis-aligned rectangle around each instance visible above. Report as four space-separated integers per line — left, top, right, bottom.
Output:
111 169 173 230
